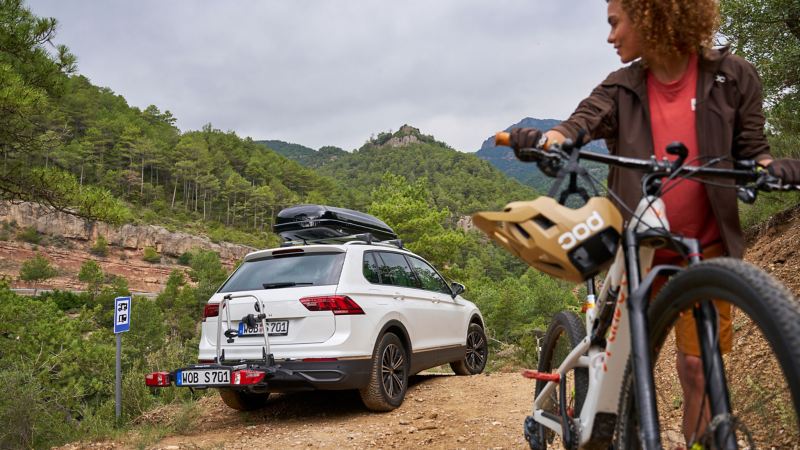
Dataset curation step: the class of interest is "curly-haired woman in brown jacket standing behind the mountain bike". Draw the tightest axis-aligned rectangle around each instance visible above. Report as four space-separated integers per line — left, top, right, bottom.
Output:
511 0 800 443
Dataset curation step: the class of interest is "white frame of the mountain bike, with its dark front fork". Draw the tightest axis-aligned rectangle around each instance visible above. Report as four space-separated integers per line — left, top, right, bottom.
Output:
533 197 721 448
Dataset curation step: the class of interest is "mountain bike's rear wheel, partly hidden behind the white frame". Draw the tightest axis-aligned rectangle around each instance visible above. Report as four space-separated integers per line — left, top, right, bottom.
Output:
532 311 589 450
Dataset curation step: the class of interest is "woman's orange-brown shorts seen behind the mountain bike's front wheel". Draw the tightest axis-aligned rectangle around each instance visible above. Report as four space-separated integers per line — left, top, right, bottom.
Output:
650 245 733 356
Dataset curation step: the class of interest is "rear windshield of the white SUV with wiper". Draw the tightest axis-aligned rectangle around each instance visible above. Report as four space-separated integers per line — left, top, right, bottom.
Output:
219 253 345 292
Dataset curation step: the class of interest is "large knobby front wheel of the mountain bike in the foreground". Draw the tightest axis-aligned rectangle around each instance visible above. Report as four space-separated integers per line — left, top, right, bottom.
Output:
616 258 800 449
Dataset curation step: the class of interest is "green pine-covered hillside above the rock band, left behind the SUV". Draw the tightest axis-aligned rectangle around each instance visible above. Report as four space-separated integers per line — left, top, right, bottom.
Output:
24 71 354 245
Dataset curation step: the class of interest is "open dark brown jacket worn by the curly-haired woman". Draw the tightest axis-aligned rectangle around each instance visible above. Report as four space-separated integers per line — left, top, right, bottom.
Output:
554 49 770 258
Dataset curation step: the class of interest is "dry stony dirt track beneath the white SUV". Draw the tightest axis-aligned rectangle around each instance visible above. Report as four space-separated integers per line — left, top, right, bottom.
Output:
133 373 533 449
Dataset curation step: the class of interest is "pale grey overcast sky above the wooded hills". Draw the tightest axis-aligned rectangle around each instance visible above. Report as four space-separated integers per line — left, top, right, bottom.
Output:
28 0 620 152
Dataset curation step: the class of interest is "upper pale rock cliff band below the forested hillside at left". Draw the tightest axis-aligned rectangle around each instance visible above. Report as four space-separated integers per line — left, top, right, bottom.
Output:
0 202 255 261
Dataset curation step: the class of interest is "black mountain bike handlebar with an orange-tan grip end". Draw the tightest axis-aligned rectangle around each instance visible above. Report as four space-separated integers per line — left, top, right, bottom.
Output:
495 131 800 191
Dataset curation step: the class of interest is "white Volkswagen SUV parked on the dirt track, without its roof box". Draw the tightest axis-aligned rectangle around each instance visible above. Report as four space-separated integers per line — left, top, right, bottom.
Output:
195 236 488 411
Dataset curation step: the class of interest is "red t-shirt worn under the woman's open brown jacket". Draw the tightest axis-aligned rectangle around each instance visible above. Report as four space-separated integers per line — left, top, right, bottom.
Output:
647 54 720 263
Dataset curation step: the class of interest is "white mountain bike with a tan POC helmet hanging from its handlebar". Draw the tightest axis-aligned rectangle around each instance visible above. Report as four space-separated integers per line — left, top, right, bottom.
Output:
473 133 800 450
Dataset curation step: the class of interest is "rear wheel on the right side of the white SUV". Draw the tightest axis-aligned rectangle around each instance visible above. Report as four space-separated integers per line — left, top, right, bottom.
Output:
358 333 410 412
